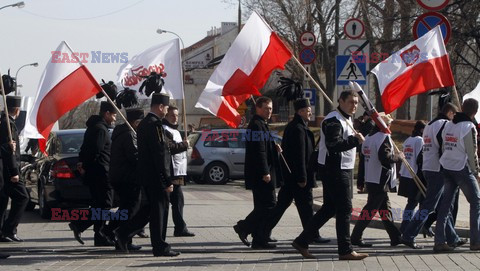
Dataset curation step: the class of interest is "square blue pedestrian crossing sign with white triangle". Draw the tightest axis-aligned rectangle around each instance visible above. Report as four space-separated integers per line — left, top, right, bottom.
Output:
336 55 367 85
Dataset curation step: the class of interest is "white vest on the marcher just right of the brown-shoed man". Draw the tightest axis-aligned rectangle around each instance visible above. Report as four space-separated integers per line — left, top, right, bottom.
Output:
362 132 397 187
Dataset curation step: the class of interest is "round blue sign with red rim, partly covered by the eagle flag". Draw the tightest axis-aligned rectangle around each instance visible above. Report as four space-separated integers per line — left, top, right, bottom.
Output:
413 12 452 44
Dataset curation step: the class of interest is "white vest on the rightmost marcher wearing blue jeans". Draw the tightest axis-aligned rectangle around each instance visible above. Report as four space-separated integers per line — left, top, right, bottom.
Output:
440 121 475 171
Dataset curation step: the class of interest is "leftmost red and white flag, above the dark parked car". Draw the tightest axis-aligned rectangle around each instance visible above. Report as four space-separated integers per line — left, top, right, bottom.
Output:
23 41 102 150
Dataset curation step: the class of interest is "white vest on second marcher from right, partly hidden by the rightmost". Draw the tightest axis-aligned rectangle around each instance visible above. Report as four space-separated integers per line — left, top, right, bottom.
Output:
422 119 448 172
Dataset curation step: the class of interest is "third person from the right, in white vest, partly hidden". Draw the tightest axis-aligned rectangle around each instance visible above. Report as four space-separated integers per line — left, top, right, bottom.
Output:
398 120 430 232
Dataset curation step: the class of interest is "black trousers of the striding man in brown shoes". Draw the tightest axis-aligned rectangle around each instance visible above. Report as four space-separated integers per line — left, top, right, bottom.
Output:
295 169 353 255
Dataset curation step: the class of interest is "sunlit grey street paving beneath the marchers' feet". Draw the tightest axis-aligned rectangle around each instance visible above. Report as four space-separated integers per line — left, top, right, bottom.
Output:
0 181 480 271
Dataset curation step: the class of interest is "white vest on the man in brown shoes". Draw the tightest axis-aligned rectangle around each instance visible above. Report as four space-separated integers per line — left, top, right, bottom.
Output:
318 111 356 169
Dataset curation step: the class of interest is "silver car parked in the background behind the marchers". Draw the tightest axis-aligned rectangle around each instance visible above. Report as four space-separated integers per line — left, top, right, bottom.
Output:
187 129 282 184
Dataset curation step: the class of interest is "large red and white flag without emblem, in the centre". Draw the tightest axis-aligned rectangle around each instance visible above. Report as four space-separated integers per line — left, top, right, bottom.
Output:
195 12 292 128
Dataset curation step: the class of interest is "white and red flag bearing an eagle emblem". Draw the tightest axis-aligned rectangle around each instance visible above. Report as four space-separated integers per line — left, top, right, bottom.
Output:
371 26 455 114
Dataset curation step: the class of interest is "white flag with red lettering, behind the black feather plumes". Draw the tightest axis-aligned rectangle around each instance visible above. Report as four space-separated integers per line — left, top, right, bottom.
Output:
117 38 183 99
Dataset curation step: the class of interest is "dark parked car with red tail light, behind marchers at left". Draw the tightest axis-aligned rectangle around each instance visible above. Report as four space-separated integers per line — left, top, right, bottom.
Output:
21 129 91 219
